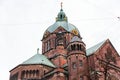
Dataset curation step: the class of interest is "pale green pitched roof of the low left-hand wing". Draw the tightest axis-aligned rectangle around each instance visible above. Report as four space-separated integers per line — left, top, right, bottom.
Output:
22 53 55 67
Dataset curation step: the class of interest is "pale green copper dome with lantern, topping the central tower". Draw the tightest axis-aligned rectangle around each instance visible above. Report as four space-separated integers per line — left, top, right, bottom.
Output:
44 9 80 36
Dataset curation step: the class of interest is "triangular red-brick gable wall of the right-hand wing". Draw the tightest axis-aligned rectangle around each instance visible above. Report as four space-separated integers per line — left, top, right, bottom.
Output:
94 39 119 63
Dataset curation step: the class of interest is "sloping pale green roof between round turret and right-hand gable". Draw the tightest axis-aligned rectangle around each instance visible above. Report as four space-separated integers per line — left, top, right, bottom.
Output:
86 40 106 56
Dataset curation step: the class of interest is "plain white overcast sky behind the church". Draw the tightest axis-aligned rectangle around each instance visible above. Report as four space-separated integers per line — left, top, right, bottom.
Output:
0 0 120 80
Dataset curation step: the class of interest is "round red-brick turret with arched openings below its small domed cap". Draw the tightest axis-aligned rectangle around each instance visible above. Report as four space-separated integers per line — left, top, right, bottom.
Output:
67 36 88 80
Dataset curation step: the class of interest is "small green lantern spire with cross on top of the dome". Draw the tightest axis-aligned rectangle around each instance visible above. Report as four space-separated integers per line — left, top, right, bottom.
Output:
56 2 67 21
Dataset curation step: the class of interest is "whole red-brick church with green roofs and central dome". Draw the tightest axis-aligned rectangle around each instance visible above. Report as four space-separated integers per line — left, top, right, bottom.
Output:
9 7 120 80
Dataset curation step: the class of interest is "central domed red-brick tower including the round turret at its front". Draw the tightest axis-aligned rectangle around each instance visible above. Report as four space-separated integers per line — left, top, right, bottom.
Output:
42 4 88 80
